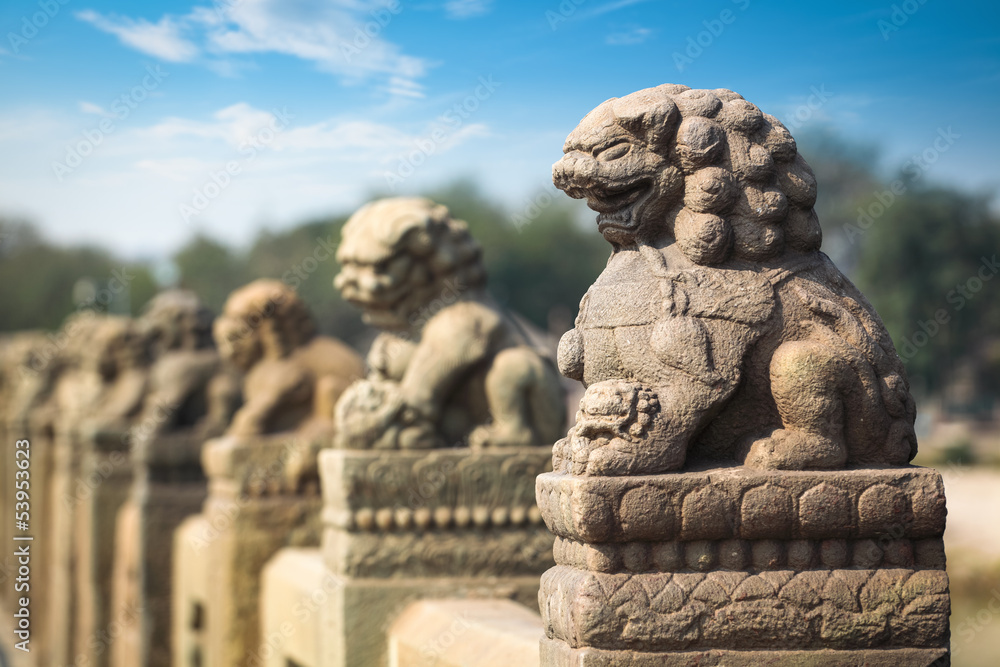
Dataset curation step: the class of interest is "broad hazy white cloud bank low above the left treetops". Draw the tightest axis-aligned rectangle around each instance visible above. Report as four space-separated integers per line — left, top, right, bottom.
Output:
0 102 496 256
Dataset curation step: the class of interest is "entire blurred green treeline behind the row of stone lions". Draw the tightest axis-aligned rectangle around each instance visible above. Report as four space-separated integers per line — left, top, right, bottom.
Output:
0 132 1000 412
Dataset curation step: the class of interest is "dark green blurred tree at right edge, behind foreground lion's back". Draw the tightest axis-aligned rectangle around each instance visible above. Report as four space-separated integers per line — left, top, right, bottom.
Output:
853 185 1000 400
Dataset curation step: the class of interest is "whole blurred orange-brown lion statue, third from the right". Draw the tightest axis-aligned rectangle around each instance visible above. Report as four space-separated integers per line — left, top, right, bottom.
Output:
213 280 364 436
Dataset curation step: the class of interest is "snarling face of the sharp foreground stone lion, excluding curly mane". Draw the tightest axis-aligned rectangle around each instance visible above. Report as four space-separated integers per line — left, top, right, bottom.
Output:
552 102 684 245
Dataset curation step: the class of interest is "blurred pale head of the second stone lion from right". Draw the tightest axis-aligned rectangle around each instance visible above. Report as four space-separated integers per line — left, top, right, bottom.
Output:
333 197 486 331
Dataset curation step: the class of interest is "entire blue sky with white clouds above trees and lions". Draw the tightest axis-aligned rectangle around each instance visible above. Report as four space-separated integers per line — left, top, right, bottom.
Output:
0 0 1000 257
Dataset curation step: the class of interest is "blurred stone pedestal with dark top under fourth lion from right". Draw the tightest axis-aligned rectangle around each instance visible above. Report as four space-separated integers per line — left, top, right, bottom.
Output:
112 433 207 667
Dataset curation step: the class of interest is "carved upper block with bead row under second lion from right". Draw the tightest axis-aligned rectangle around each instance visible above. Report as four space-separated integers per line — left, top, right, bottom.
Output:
320 447 553 578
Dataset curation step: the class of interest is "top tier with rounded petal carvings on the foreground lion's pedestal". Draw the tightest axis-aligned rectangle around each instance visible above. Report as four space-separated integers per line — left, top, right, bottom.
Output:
537 466 945 542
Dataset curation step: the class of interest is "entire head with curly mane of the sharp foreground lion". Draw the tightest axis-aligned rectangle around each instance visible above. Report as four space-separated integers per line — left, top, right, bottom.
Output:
552 84 822 265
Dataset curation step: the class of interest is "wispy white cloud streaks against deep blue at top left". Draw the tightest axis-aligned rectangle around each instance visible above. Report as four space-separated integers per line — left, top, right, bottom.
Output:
77 0 426 97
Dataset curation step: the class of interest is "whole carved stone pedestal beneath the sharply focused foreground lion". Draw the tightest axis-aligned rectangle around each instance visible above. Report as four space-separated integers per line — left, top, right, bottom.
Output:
537 467 950 667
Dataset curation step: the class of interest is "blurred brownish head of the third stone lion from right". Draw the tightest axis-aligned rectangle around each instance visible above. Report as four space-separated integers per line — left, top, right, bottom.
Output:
213 280 316 371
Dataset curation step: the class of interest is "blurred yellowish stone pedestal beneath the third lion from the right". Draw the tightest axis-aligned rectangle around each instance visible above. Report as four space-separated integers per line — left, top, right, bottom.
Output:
172 435 320 667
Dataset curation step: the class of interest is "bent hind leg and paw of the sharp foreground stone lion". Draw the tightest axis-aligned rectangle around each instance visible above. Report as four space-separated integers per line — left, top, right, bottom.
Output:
744 340 857 470
